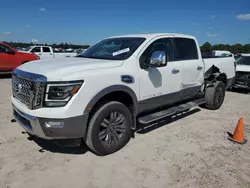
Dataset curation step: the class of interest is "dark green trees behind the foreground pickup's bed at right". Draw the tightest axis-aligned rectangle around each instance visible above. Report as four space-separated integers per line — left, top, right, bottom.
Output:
200 42 250 54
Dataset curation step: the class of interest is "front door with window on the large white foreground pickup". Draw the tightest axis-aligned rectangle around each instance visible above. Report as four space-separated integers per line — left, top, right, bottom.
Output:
139 37 181 112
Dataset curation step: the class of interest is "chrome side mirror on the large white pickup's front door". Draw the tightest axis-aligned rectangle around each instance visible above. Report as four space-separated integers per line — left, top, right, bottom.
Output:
149 51 167 67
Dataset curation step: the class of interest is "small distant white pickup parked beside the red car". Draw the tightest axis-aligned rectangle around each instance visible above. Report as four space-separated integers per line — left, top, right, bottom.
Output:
22 46 77 59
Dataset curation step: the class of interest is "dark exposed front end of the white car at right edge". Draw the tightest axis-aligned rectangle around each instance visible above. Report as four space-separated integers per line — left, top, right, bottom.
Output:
233 72 250 89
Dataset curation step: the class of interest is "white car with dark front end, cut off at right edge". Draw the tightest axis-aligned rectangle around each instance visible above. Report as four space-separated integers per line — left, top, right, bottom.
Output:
233 54 250 89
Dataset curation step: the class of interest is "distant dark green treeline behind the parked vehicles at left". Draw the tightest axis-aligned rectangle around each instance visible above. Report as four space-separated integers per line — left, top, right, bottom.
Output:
1 41 89 49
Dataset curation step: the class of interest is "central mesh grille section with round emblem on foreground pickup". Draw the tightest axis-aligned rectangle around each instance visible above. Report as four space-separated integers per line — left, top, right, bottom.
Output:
12 75 34 106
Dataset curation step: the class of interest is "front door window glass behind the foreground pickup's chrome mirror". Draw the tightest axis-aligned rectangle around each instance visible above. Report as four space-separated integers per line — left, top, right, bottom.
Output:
140 38 174 68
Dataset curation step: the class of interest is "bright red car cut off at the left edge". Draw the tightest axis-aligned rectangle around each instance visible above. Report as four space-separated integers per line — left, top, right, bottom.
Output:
0 42 40 74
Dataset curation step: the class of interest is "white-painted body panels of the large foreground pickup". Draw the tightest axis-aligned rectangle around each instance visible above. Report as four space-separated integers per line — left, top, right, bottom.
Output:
11 33 234 118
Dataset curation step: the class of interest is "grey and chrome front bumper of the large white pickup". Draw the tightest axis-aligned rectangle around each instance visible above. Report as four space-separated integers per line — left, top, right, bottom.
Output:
12 105 88 140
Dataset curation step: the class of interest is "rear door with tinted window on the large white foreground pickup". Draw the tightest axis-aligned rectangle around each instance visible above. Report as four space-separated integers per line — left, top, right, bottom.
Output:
175 37 204 100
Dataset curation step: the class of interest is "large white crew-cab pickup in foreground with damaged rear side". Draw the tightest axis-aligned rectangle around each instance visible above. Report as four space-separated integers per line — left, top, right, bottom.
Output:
11 33 235 155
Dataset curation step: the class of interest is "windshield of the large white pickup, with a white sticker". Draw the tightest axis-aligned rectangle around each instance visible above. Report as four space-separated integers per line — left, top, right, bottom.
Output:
78 37 146 60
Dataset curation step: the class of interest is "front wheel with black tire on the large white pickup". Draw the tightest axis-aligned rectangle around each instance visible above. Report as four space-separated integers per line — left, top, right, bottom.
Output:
85 101 133 155
